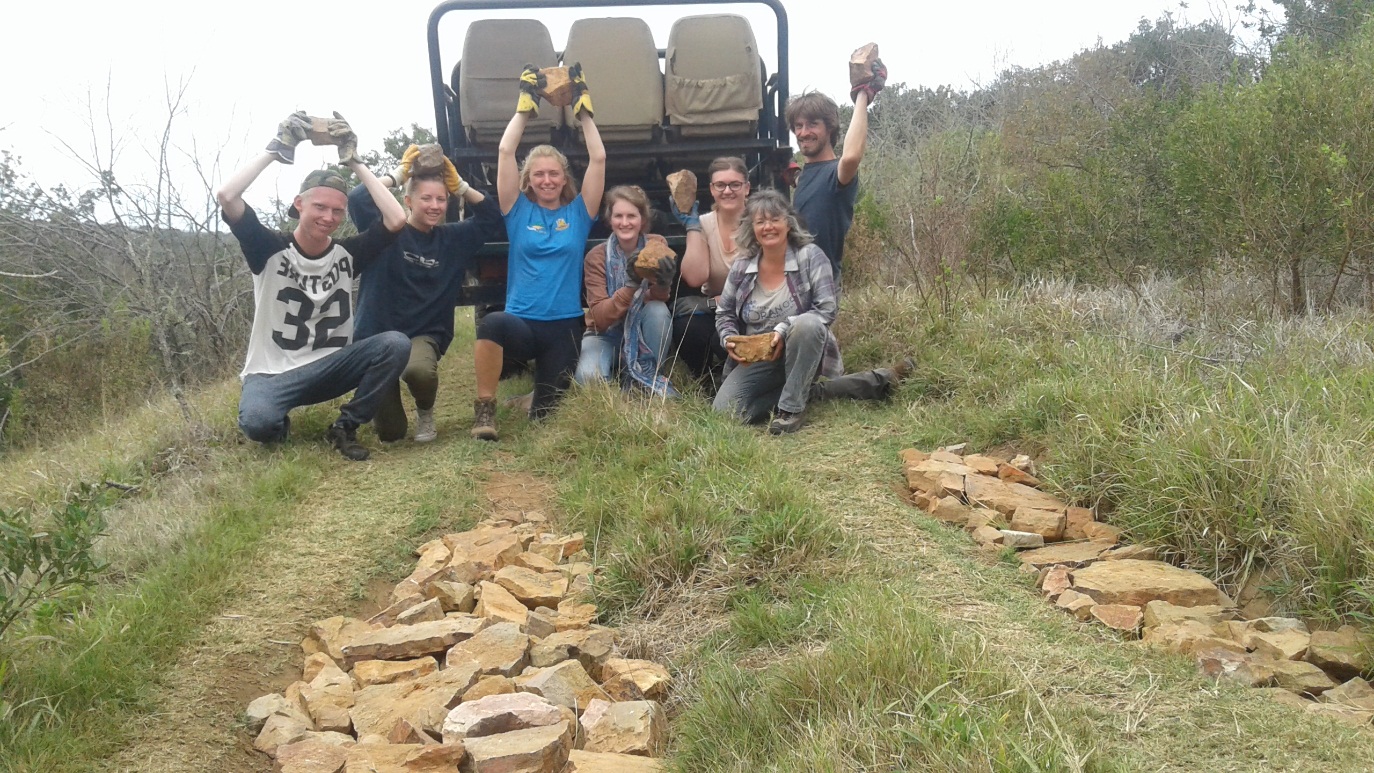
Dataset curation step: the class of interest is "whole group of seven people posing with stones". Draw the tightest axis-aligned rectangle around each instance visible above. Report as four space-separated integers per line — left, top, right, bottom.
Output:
218 62 905 460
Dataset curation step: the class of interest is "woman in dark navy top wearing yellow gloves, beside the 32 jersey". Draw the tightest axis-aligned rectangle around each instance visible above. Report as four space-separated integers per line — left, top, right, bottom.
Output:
348 146 506 443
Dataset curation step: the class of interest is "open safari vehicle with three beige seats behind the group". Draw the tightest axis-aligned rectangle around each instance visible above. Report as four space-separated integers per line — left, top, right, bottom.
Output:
427 0 791 308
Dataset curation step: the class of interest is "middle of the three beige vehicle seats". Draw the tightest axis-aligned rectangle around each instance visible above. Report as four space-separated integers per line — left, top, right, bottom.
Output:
563 18 664 143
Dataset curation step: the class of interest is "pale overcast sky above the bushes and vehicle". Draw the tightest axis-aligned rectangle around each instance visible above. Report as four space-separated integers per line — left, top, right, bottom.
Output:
0 0 1269 208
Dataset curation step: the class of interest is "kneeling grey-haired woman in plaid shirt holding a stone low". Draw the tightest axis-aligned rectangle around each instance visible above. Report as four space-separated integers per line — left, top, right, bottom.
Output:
712 191 911 435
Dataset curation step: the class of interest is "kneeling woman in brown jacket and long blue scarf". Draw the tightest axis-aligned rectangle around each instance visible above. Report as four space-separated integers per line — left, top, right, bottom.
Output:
574 185 676 394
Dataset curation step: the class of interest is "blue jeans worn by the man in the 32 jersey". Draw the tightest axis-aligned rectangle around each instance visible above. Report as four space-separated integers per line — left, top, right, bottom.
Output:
239 331 411 443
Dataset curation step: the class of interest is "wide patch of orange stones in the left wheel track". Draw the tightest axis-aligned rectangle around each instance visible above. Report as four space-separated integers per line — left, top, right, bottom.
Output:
247 520 671 773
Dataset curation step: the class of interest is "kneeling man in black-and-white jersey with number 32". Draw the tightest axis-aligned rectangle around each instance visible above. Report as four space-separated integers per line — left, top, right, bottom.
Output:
217 113 411 461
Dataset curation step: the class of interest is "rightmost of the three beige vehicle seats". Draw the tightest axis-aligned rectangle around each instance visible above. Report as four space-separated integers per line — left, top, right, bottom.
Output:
664 14 764 137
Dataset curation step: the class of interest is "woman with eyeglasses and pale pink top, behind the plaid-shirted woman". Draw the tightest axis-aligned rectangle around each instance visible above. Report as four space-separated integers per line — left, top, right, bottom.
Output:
669 157 749 389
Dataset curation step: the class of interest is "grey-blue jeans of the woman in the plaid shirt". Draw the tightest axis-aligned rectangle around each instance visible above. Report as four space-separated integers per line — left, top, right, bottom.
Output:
712 314 826 424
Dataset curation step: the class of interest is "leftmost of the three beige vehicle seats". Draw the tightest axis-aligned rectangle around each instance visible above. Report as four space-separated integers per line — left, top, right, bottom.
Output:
458 19 562 147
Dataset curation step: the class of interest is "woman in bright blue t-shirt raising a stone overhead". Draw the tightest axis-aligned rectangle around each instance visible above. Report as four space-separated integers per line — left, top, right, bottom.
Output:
473 65 606 441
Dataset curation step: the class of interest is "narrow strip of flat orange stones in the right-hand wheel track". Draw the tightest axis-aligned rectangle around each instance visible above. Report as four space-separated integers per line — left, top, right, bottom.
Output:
901 446 1374 726
